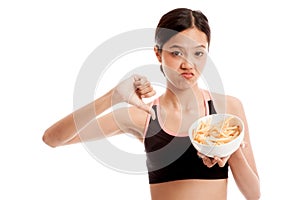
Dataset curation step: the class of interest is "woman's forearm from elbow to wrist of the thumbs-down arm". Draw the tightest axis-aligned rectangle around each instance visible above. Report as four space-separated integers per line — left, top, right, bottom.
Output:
43 90 113 147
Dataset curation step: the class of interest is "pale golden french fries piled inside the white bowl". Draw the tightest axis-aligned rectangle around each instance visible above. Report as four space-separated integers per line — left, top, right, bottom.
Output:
192 117 240 145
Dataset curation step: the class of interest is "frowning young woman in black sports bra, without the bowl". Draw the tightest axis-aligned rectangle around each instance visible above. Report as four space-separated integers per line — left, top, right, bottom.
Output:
43 8 260 200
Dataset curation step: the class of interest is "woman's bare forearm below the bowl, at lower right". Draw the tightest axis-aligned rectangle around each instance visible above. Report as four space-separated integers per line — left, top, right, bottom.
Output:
228 148 260 200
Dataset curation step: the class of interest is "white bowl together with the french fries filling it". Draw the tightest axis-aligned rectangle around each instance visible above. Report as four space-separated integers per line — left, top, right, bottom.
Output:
189 114 244 157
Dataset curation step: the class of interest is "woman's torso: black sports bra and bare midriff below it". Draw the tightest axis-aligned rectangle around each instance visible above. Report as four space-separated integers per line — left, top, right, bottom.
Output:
144 94 228 200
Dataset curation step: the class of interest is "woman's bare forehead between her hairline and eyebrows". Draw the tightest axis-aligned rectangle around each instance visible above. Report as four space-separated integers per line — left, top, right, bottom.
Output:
165 28 208 48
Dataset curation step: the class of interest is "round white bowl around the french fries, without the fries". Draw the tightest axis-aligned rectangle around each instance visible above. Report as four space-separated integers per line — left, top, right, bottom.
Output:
189 114 244 158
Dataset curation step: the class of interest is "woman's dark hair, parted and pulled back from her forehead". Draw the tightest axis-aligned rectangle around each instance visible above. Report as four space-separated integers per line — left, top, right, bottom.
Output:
155 8 210 50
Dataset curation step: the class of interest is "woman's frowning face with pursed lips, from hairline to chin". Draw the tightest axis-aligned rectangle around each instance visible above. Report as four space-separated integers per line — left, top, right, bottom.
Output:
156 28 208 89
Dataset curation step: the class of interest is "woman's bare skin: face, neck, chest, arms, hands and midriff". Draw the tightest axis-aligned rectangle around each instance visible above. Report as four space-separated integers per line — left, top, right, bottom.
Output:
43 28 260 200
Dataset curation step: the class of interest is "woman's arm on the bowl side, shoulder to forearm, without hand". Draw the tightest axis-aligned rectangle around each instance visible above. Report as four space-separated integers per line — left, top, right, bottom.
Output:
227 97 260 200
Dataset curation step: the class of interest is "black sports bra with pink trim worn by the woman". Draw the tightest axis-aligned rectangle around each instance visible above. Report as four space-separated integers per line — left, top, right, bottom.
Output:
144 100 228 184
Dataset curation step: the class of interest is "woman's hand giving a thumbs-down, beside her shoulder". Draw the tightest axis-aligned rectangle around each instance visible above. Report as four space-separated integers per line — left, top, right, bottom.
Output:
113 75 156 119
